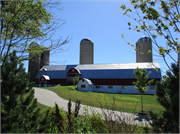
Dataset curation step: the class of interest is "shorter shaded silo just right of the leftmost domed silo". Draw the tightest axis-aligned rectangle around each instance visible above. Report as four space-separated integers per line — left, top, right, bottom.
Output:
40 48 50 68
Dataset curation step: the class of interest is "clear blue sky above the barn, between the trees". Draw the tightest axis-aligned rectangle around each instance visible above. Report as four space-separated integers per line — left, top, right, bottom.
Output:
25 0 177 76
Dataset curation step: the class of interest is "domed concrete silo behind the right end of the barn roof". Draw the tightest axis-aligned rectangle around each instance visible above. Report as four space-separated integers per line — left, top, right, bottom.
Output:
136 36 153 62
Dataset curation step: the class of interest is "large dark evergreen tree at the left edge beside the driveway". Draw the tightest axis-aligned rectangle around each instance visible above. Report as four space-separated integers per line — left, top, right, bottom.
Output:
1 51 49 133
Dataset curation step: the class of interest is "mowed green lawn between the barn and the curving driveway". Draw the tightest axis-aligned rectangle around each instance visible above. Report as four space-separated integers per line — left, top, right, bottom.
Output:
36 85 164 113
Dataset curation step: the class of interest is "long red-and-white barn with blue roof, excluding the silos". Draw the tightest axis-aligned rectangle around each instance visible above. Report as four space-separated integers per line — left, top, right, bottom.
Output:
36 62 161 94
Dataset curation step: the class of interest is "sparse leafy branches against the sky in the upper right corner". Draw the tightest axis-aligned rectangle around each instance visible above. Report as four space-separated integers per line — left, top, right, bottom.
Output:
120 0 180 76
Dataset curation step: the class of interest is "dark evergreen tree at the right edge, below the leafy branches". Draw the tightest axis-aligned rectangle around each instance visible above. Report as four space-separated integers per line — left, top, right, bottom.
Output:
150 64 179 133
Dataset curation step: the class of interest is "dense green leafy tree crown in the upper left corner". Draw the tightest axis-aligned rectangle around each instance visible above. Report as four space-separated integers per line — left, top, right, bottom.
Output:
1 0 52 59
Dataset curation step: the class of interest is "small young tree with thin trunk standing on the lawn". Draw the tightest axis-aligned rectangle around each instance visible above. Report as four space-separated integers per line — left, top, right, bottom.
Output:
133 67 154 113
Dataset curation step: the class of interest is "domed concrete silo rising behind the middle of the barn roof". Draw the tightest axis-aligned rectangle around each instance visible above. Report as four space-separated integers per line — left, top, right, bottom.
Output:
80 38 94 64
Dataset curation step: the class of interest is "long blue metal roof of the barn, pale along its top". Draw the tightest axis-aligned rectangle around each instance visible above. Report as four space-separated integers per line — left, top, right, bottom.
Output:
36 63 161 79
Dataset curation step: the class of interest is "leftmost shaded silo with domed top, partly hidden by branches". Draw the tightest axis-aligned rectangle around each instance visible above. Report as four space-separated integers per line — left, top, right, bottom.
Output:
28 41 41 82
